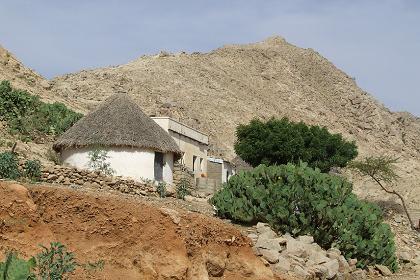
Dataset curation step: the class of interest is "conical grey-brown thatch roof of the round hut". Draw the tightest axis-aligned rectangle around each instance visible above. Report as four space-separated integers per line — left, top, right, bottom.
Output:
53 93 181 154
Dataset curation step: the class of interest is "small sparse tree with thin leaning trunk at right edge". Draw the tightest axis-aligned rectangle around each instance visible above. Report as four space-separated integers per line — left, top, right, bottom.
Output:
349 156 419 230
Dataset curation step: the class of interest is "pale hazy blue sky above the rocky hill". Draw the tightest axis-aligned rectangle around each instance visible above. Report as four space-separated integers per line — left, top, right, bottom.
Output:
0 0 420 116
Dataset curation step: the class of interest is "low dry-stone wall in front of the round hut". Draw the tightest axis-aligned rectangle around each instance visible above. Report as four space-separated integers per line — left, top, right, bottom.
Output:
42 165 157 196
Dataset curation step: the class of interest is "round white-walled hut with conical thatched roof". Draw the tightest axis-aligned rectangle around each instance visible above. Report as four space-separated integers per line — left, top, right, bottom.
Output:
53 94 181 183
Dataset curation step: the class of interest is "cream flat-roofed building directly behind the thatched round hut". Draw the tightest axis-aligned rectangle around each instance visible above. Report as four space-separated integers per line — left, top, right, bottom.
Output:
152 117 209 178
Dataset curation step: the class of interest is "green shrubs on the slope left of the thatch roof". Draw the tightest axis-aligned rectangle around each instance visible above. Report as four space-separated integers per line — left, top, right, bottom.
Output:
0 81 83 141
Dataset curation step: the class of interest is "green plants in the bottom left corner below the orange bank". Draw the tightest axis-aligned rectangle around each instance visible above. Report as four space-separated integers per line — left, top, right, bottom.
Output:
0 242 104 280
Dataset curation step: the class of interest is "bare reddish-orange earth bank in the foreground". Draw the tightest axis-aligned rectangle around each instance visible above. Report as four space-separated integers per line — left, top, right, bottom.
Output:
0 183 278 280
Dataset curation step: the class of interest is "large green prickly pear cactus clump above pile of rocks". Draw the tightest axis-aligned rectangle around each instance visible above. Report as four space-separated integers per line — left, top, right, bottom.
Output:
211 164 397 271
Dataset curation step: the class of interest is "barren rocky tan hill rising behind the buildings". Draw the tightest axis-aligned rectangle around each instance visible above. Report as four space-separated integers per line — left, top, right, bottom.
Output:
47 37 420 207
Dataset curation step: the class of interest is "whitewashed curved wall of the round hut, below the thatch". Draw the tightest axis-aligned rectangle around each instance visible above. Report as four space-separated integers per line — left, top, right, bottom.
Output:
61 147 173 183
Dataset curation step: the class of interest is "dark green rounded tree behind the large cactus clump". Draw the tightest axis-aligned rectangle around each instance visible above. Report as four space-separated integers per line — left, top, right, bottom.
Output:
235 118 357 172
